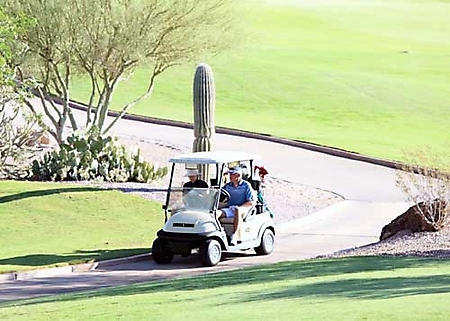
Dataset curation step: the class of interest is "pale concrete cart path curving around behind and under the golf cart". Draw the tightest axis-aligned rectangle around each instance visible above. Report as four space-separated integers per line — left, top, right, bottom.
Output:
0 103 408 302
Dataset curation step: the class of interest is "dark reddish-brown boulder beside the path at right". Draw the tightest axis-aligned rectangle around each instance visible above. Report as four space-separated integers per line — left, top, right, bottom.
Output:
380 199 449 241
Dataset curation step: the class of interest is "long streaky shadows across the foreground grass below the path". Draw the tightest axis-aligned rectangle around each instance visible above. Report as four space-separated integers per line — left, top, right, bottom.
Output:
11 257 450 304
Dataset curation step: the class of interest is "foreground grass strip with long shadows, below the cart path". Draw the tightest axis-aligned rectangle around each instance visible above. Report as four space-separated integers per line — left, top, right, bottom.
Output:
0 257 450 320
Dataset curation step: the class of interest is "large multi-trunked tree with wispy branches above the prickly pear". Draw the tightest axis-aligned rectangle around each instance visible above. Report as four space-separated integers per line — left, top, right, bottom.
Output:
0 0 234 142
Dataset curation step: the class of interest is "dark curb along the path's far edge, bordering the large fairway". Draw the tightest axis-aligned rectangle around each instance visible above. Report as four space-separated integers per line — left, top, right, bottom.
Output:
49 96 405 169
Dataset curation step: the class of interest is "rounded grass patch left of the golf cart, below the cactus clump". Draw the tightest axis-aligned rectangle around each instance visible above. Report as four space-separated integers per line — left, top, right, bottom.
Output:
0 181 163 273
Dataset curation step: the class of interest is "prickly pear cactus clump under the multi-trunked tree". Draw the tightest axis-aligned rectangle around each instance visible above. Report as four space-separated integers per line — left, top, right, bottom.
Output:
32 133 167 183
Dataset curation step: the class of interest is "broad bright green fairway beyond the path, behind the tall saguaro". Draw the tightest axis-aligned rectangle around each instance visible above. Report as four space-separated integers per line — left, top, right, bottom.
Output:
73 0 450 159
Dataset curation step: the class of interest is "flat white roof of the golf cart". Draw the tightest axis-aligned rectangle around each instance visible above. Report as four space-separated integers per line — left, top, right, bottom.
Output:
169 151 259 164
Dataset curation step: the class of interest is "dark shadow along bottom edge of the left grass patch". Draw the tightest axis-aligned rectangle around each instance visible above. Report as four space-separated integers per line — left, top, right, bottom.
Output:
0 248 150 268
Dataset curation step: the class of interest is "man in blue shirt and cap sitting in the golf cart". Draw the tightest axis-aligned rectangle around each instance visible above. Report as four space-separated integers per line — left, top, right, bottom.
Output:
218 167 255 245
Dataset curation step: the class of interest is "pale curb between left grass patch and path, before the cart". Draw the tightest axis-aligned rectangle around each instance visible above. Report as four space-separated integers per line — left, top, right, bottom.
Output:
0 253 152 283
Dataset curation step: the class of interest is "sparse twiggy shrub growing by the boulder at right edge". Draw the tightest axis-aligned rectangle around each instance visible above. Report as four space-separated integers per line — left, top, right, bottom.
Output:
396 150 450 231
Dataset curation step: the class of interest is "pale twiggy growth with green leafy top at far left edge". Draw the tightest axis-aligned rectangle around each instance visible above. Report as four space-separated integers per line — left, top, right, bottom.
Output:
0 10 41 177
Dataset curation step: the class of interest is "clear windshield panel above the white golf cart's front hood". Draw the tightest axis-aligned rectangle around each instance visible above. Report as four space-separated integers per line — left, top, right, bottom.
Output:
167 188 219 215
